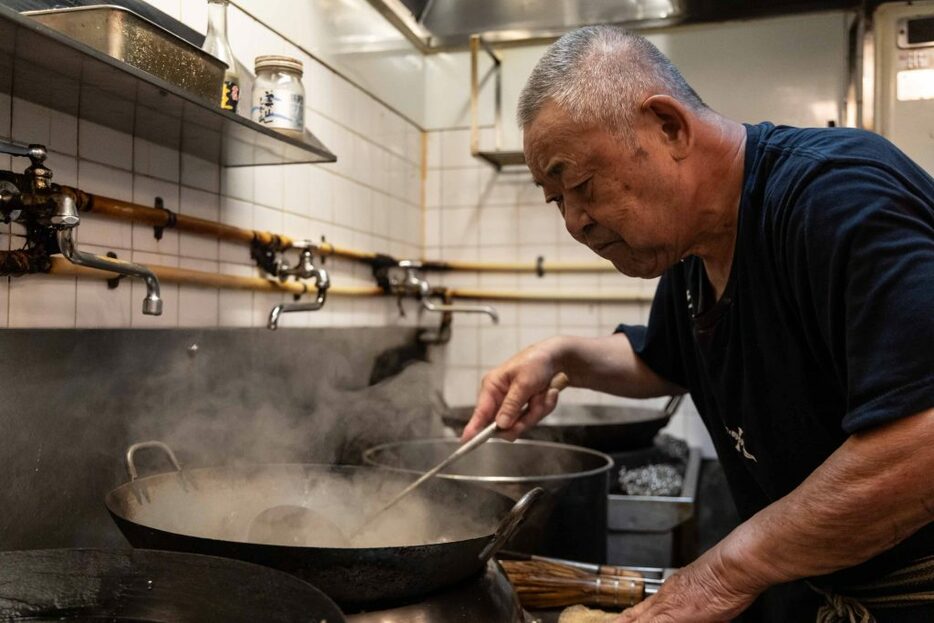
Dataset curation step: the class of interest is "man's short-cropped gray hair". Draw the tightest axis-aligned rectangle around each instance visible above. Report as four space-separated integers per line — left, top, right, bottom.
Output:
517 26 707 136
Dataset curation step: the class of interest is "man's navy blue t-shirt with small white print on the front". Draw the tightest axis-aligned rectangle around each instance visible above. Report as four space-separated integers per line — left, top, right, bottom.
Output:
619 123 934 620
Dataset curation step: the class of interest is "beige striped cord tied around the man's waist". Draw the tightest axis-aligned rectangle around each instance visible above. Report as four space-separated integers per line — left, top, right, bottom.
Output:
807 556 934 623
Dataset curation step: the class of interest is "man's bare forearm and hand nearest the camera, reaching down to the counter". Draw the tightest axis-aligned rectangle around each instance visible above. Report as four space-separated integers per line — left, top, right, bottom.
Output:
619 408 934 623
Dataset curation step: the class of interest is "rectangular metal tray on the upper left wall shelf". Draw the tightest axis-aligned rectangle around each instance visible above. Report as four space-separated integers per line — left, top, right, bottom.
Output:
25 5 227 106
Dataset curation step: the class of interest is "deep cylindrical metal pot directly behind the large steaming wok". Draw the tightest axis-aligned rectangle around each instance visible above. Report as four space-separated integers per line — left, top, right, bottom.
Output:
363 439 613 563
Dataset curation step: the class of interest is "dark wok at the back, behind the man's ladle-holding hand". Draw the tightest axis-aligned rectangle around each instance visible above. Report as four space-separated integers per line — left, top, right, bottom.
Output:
442 396 682 453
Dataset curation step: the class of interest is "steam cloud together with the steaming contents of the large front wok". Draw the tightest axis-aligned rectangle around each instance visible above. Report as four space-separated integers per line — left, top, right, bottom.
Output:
118 330 509 547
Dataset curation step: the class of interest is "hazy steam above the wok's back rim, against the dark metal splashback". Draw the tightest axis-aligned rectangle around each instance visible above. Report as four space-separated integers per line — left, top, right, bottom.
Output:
130 346 443 471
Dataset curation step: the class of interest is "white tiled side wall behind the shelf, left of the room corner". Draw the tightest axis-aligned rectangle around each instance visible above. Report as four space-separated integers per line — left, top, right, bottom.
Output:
0 0 422 328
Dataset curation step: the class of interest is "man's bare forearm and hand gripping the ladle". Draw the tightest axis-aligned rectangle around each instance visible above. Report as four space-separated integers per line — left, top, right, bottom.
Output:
462 333 684 440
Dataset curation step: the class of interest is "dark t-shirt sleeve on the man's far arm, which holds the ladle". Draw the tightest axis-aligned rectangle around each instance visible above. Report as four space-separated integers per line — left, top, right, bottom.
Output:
614 269 687 387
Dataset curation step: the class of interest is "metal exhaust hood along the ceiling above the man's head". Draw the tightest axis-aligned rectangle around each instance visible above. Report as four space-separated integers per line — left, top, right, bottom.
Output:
369 0 861 52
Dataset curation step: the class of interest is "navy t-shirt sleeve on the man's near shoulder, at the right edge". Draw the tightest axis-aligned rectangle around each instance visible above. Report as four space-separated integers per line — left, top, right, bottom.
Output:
784 163 934 433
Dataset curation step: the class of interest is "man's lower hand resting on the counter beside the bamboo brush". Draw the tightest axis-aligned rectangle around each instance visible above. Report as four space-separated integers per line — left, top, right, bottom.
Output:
617 548 761 623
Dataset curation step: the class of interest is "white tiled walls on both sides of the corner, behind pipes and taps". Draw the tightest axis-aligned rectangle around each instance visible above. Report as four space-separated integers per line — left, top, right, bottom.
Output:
0 0 705 458
